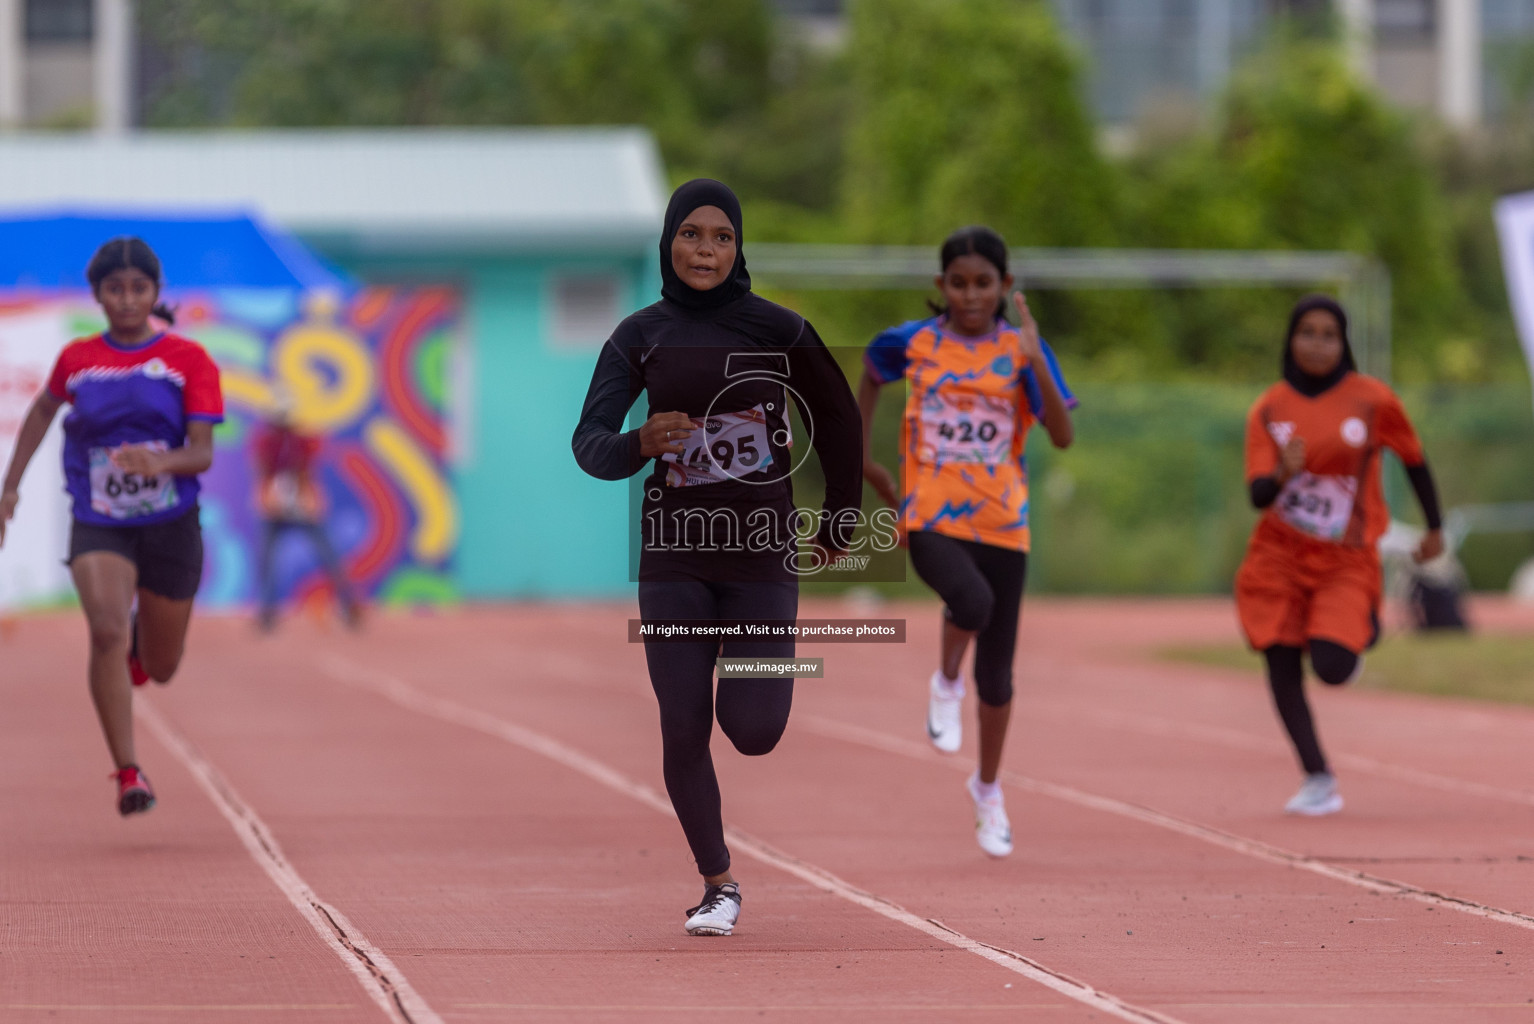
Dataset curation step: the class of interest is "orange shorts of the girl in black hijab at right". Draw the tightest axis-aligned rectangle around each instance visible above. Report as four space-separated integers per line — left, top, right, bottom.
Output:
1236 517 1381 655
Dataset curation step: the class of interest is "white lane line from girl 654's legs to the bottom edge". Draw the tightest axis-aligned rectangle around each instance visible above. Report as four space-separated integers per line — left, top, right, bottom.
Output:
133 694 443 1024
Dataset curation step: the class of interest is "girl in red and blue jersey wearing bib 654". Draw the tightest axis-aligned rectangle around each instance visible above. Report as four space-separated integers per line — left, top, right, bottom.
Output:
0 238 224 816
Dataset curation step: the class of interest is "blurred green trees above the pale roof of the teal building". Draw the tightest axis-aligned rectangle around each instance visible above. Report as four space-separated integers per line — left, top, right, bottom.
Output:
140 0 772 167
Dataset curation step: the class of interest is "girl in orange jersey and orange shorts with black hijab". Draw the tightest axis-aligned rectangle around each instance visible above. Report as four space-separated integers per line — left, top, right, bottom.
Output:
1236 296 1443 816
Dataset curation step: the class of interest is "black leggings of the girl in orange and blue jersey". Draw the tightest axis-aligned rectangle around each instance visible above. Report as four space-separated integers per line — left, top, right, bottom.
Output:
910 530 1028 708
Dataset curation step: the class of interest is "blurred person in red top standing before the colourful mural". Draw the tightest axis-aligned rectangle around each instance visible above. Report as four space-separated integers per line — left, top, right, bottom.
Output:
252 395 360 632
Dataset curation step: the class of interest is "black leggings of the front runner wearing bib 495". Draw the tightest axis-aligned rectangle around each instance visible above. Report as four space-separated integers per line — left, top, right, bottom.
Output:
640 581 799 877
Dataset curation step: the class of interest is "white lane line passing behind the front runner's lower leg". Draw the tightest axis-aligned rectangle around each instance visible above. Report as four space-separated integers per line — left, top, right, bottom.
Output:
319 655 1181 1024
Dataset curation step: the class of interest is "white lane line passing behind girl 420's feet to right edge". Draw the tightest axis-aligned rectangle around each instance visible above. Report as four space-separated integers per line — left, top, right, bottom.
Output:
795 714 1534 930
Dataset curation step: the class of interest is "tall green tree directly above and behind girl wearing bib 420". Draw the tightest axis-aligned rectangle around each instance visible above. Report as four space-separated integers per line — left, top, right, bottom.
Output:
842 0 1115 245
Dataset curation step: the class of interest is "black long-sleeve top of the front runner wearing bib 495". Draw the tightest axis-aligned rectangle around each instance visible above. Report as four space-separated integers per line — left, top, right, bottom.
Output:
571 294 862 583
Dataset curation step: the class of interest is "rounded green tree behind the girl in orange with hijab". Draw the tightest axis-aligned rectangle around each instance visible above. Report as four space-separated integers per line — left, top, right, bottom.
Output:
1129 37 1468 374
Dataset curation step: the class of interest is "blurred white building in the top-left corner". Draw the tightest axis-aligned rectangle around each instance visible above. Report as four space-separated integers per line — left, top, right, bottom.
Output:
0 0 135 132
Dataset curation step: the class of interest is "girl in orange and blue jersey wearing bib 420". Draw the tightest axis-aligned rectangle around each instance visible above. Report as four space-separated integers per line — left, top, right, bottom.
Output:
858 227 1075 857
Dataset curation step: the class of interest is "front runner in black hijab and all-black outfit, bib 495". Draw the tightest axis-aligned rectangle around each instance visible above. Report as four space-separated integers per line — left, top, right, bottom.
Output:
572 178 862 935
